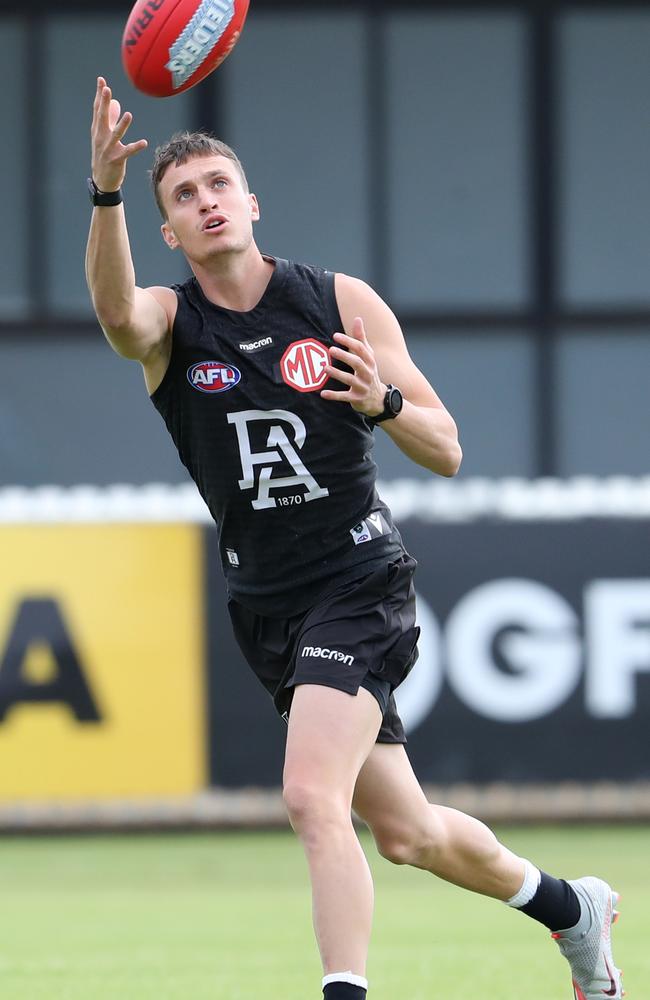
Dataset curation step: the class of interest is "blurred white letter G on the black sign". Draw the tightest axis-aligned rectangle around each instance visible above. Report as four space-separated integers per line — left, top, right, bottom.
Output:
445 579 582 722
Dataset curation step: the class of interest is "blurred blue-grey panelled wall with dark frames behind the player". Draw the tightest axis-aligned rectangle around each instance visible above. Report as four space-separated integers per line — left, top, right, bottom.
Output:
0 0 650 485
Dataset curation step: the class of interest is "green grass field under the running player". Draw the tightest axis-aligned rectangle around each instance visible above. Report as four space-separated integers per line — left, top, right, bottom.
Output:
0 826 650 1000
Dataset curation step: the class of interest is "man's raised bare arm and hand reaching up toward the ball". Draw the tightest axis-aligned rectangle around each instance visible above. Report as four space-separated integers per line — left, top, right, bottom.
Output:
86 76 175 376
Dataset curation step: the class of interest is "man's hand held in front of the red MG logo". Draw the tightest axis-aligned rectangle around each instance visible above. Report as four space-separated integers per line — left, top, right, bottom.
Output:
321 317 386 417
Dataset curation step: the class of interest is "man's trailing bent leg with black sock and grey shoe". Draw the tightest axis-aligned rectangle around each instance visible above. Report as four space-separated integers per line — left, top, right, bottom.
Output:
353 744 623 1000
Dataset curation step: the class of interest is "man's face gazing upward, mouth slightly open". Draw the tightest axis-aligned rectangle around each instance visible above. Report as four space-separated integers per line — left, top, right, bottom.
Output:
159 156 260 264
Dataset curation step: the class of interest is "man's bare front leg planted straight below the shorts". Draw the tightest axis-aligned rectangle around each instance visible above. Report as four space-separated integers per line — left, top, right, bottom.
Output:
284 684 381 980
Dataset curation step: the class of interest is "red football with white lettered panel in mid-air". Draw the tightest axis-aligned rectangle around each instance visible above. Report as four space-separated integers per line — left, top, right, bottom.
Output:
122 0 249 97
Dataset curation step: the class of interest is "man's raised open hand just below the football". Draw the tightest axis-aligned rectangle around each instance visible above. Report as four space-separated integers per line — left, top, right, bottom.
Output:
91 76 147 191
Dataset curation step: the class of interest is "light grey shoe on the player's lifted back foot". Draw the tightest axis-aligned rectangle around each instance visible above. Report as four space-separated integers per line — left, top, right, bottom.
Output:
553 876 625 1000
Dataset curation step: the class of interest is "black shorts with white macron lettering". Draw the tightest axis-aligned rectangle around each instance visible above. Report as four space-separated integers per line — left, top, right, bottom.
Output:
228 553 420 743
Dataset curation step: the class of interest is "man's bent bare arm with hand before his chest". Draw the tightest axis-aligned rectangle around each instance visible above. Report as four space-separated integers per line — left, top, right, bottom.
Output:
321 274 462 476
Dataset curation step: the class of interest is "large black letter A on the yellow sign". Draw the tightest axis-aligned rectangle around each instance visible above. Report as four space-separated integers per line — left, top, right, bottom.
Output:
0 599 101 722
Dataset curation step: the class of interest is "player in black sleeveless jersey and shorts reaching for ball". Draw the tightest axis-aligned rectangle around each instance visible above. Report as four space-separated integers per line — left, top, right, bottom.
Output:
86 77 622 1000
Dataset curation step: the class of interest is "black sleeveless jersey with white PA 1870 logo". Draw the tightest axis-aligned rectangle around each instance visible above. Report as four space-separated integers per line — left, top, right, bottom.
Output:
151 258 403 615
